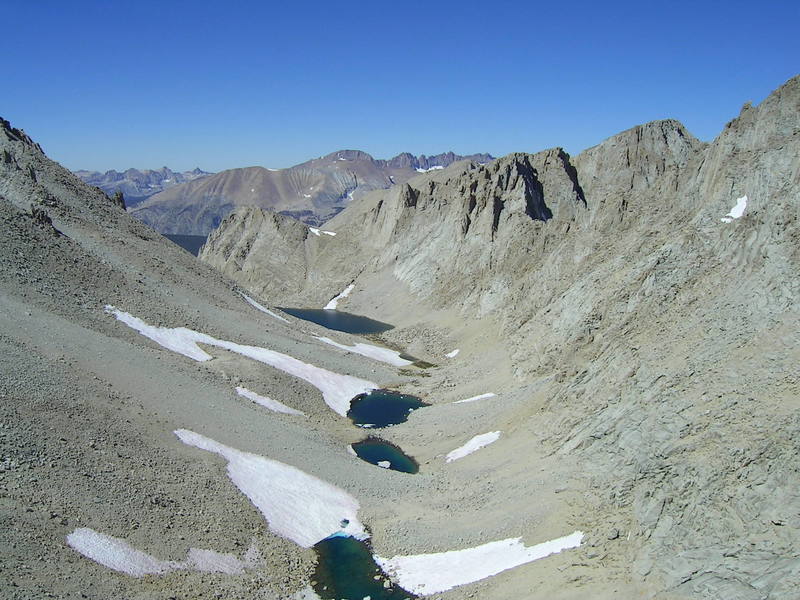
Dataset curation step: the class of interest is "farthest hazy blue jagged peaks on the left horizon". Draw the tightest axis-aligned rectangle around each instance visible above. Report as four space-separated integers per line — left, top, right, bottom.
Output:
74 167 211 207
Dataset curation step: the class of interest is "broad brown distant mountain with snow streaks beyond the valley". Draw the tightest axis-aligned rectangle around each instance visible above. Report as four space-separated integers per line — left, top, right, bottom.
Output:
128 150 493 235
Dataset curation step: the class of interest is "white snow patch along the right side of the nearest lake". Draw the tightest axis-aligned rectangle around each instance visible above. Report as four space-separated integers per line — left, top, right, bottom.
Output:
375 531 583 596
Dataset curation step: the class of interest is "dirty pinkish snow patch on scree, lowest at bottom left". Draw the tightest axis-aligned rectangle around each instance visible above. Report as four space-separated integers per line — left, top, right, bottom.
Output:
67 527 261 577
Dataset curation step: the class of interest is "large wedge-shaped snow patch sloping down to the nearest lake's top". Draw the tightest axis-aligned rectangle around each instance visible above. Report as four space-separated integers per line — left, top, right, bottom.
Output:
175 429 368 548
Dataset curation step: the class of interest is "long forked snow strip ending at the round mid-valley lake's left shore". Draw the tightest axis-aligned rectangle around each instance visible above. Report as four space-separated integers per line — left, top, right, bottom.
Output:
106 306 378 417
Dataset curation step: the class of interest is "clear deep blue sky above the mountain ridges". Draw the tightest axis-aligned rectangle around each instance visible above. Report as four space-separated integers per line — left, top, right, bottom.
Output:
0 0 800 171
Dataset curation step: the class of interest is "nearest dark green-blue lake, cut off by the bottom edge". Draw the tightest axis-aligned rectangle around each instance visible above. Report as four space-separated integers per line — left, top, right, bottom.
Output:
311 536 416 600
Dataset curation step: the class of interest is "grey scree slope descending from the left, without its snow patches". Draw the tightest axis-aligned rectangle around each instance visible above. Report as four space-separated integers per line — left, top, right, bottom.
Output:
0 121 462 600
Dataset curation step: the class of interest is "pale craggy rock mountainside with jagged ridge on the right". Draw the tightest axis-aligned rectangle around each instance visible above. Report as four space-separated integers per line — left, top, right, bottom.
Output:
202 78 800 600
